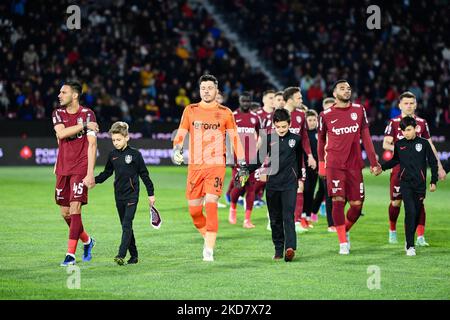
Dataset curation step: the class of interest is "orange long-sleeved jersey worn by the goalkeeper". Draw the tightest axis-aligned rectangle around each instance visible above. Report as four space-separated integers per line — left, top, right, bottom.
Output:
174 101 244 170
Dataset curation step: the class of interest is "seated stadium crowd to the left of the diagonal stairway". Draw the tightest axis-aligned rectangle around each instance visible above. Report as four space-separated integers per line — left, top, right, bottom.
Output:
0 0 269 123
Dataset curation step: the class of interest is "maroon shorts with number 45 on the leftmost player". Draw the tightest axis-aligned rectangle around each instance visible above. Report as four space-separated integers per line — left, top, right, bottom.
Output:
55 175 88 207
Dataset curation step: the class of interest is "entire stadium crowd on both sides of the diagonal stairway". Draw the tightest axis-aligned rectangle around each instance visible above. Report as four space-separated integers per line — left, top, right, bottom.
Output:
0 0 450 127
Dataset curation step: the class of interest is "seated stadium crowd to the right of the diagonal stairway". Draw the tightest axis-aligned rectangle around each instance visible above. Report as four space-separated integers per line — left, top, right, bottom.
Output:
213 0 450 127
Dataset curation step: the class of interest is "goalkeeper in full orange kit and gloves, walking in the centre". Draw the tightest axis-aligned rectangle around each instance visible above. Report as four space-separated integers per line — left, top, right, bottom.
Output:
173 75 249 261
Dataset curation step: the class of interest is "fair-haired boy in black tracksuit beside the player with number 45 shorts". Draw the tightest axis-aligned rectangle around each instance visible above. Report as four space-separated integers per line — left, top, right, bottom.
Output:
95 121 155 265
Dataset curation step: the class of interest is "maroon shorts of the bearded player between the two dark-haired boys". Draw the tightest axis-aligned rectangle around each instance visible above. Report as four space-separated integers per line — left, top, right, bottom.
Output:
327 168 364 201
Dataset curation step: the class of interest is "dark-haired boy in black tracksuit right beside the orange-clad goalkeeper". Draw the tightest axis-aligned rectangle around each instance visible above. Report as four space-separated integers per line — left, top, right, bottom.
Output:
257 109 303 262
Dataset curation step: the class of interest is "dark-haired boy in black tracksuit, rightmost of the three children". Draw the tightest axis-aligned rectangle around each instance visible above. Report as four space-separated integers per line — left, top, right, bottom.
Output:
378 117 438 256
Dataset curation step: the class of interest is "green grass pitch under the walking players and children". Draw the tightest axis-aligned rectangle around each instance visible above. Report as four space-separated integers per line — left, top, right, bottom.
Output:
0 167 450 300
